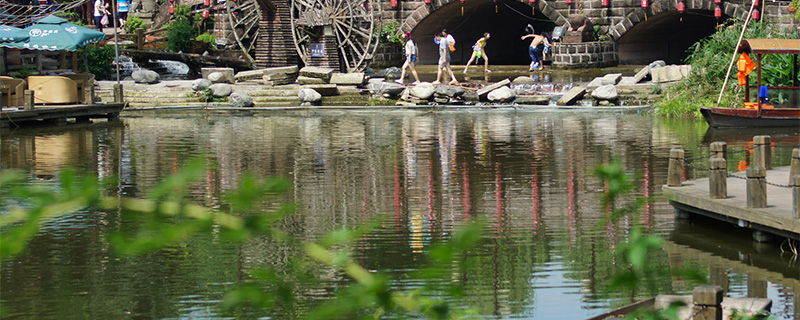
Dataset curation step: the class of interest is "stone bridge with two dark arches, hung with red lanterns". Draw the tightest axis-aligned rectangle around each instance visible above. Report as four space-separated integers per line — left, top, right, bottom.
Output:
256 0 800 67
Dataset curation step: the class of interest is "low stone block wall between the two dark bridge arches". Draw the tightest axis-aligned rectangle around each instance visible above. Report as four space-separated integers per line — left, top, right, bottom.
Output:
552 41 619 69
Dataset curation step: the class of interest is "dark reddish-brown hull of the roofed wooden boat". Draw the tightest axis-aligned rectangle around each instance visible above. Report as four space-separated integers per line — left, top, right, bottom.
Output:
700 107 800 128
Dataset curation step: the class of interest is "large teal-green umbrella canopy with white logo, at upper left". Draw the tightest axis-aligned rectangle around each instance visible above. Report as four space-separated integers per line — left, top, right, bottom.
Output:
0 15 106 51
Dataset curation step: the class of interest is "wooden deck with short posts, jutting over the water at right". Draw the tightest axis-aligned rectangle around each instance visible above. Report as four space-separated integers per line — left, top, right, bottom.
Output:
662 166 800 240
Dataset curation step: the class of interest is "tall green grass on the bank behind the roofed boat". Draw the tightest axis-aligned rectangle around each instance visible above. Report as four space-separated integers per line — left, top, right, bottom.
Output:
654 20 800 117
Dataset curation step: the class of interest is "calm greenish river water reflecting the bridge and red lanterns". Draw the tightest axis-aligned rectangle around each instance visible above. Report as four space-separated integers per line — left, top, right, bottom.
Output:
0 108 800 319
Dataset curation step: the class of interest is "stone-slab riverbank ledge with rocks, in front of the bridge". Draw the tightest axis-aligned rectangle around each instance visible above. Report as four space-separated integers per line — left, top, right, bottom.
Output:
96 66 660 109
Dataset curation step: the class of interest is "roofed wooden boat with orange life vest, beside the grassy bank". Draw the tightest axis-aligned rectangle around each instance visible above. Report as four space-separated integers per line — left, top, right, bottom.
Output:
700 39 800 129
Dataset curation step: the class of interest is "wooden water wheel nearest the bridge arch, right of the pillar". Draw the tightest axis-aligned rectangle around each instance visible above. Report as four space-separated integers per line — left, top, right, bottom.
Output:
290 0 381 72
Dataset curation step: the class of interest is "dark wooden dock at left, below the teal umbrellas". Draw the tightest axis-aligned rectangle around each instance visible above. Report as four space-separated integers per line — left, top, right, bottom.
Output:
0 103 125 128
